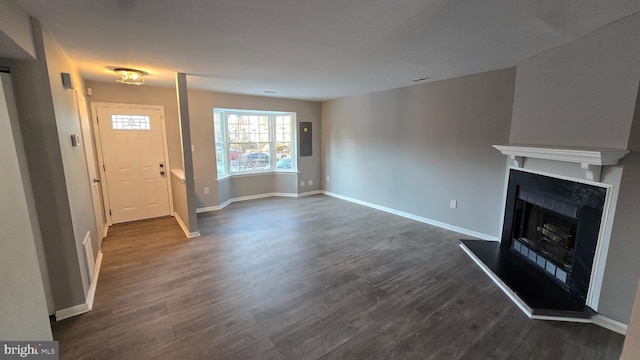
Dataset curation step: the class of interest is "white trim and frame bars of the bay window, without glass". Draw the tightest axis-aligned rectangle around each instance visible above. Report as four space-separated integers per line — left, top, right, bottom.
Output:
213 108 299 181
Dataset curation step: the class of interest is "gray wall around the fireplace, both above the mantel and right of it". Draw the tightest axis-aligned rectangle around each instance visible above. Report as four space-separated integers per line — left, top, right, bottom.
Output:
510 14 640 323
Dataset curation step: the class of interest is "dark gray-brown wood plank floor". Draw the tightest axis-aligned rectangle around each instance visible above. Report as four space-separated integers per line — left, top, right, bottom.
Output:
52 195 624 360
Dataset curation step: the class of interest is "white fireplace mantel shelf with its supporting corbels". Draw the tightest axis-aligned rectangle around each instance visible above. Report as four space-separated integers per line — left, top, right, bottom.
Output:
493 145 629 182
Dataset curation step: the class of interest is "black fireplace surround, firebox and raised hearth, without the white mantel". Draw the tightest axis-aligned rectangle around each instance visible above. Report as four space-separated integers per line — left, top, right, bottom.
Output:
461 169 607 319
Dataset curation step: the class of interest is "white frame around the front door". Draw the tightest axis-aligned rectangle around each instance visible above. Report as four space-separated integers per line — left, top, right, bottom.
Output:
91 101 173 226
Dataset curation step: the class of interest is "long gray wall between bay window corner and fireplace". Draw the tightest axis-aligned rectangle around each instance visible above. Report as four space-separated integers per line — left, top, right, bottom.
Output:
322 68 515 237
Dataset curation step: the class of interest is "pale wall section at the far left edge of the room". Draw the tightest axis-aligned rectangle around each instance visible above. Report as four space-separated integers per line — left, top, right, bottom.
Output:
0 74 52 341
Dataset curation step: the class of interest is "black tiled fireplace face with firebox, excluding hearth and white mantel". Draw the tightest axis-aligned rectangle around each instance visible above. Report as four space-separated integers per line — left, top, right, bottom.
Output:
501 169 607 301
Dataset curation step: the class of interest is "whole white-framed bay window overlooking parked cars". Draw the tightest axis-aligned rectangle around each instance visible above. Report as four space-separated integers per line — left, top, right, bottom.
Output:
213 109 296 178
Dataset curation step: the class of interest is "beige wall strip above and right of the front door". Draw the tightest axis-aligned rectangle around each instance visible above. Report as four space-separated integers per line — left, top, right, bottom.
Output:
85 79 183 169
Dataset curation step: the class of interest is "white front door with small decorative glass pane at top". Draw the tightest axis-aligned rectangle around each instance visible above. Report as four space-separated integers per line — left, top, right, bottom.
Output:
95 105 170 224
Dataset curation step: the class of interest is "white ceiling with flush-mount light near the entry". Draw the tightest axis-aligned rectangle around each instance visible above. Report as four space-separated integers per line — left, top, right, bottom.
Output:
19 0 640 100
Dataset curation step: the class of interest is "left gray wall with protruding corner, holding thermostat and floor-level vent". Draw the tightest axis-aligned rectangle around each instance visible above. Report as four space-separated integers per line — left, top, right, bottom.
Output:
12 19 90 310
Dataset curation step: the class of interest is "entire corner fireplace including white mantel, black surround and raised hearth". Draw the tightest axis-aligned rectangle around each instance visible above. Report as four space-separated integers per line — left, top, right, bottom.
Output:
460 144 629 322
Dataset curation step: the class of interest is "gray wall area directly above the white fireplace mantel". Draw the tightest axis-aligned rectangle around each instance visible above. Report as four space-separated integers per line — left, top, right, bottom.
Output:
510 15 640 149
